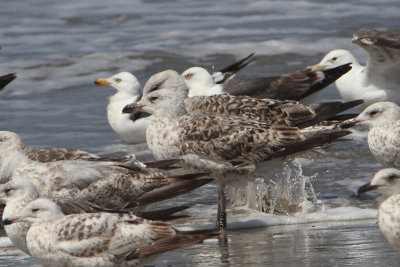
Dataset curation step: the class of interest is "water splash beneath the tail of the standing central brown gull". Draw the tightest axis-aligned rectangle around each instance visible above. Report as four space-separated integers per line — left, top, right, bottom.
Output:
228 159 325 216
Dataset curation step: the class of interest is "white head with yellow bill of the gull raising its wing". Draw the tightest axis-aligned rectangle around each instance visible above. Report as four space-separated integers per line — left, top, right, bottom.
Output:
313 49 358 71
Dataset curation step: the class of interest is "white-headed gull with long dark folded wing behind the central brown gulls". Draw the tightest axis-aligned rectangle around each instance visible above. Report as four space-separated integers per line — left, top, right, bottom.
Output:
182 64 351 104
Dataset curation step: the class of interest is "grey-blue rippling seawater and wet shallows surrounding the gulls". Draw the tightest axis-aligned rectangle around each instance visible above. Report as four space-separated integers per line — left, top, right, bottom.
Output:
0 0 400 266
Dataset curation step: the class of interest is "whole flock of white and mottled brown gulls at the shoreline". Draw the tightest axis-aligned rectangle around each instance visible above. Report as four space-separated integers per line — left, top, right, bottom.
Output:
0 30 400 266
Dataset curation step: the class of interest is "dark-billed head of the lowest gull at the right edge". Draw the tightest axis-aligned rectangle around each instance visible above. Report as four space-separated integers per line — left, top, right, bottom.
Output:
357 168 400 196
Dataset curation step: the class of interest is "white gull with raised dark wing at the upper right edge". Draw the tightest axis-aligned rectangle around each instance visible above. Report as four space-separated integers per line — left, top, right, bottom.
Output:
315 30 400 110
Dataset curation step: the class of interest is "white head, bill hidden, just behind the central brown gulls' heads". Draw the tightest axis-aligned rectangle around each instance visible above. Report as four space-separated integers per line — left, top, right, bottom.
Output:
182 67 215 97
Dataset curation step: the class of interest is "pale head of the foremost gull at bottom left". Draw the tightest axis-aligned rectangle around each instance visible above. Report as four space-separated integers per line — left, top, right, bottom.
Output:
3 198 64 225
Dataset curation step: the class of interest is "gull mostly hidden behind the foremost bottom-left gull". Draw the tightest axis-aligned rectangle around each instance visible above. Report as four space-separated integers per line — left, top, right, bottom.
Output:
0 179 200 254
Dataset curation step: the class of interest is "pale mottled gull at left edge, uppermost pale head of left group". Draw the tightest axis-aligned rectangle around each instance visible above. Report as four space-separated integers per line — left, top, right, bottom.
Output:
0 131 214 208
